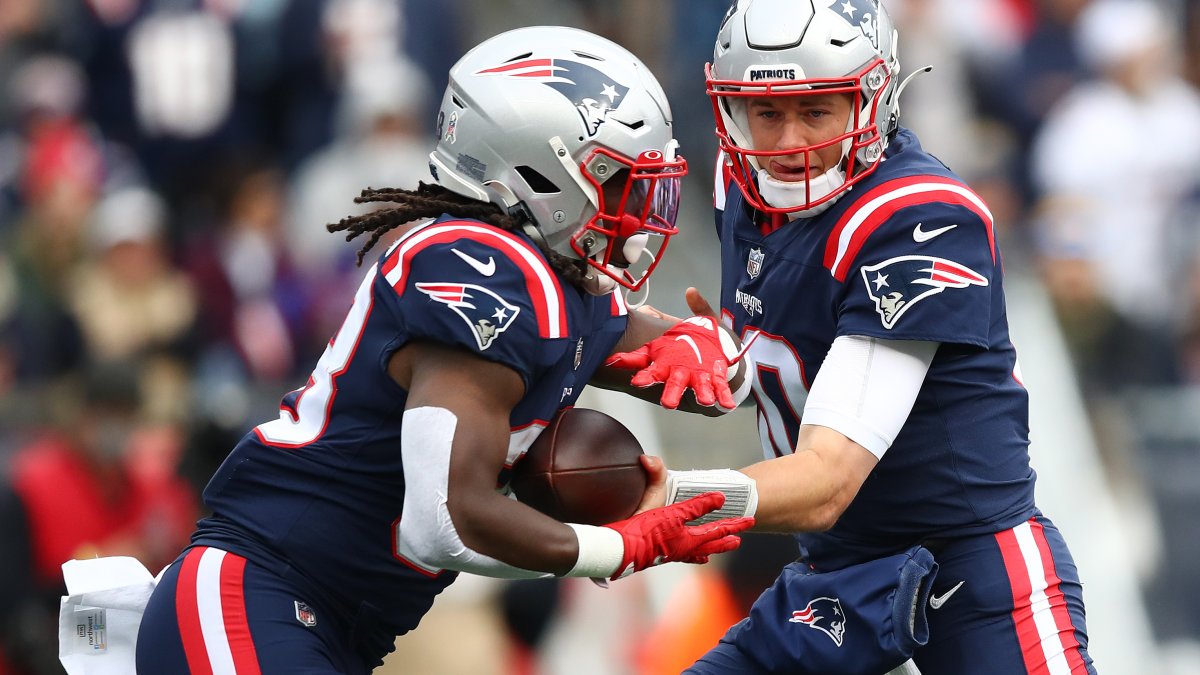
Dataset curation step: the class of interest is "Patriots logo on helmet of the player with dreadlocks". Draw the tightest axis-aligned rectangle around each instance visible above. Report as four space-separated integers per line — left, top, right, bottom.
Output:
475 59 629 137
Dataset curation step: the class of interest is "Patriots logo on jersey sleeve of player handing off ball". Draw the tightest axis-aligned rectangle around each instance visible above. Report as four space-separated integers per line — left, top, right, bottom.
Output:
863 256 988 329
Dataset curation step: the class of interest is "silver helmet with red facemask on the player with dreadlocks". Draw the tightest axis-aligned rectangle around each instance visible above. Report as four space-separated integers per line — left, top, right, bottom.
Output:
430 26 688 294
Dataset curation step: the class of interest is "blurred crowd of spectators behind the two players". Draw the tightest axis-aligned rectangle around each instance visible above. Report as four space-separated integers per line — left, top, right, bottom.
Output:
0 0 1200 675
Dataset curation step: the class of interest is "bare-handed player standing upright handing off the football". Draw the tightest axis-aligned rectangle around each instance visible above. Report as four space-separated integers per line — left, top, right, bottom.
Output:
614 0 1094 675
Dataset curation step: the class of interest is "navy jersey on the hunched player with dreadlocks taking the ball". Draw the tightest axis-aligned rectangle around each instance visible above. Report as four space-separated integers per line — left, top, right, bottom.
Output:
193 216 628 644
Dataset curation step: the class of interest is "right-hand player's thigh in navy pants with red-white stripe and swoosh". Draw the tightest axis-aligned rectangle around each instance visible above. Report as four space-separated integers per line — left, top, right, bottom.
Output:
914 516 1096 675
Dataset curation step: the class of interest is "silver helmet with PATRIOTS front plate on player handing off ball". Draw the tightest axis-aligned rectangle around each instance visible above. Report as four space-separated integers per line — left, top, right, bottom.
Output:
704 0 900 216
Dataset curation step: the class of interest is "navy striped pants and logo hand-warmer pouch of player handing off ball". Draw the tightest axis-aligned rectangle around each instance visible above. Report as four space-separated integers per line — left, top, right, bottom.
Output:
685 516 1096 675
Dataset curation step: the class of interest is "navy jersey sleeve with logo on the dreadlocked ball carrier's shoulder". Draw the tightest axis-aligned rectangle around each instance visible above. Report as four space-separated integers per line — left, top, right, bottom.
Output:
380 223 568 387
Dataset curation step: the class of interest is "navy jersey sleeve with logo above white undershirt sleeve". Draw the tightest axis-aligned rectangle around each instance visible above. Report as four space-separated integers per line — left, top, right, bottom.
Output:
826 202 1000 347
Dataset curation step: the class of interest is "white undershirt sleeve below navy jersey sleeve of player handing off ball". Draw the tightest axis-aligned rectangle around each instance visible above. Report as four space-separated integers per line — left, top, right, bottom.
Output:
803 335 938 459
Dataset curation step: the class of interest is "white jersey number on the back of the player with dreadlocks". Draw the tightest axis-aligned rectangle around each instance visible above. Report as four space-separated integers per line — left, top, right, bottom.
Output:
254 268 376 448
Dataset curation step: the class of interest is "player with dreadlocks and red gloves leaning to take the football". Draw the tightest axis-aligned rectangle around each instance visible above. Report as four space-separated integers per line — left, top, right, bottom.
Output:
137 26 752 674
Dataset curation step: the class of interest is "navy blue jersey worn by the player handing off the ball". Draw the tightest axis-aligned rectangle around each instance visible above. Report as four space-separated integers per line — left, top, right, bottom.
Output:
716 130 1034 567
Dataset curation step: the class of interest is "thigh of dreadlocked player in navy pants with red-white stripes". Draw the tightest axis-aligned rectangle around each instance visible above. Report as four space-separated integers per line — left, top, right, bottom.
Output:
137 546 357 675
